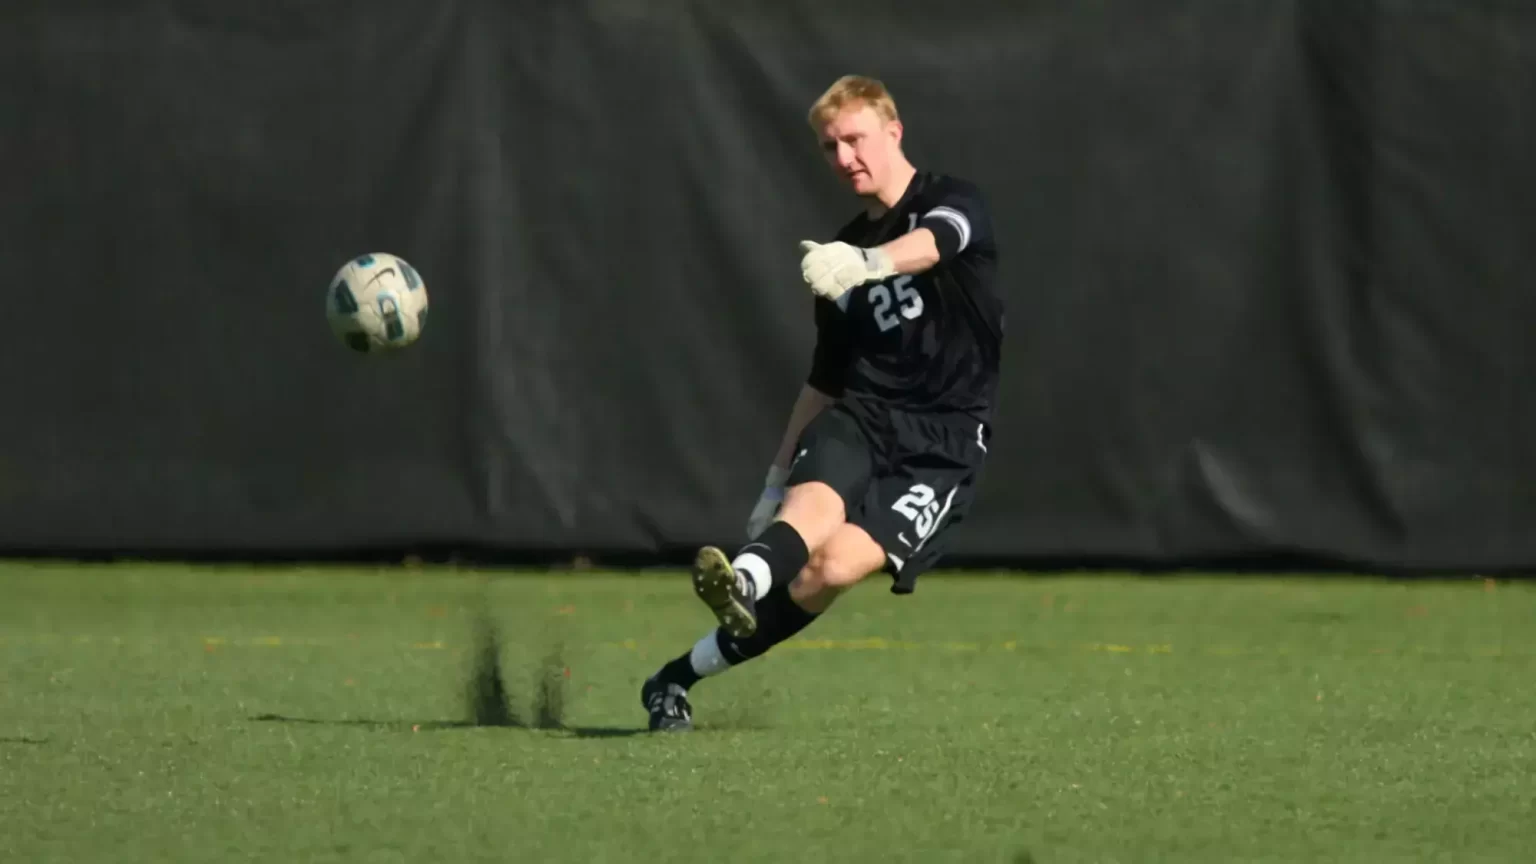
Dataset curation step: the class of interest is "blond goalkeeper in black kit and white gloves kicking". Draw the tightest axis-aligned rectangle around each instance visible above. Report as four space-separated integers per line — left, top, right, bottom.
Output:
641 75 1003 730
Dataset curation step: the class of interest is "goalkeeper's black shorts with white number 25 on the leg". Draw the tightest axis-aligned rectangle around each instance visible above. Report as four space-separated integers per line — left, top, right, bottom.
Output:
788 404 991 593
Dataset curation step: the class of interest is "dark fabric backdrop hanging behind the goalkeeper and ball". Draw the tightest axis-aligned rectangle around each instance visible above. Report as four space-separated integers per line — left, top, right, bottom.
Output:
0 0 1536 569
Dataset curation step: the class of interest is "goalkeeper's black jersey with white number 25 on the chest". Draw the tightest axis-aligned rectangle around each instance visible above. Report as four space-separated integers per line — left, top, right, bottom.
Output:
808 172 1003 421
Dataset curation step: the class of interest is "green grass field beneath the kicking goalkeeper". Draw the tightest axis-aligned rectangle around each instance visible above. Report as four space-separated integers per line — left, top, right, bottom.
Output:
0 564 1536 864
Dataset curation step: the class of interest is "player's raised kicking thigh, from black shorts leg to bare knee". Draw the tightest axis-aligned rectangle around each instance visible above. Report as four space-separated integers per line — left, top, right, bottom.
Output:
779 407 874 552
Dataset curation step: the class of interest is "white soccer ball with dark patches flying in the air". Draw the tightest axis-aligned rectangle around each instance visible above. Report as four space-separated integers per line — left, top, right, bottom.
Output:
326 252 427 354
